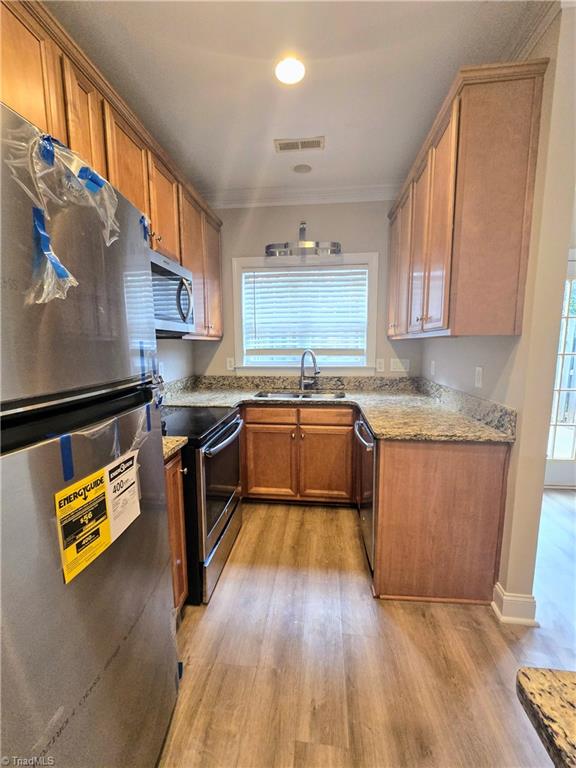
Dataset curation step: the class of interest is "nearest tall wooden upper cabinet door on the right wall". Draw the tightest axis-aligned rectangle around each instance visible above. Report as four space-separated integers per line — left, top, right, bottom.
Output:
423 102 458 331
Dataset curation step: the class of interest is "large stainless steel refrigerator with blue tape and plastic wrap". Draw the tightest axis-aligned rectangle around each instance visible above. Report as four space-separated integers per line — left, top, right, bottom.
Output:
0 107 177 768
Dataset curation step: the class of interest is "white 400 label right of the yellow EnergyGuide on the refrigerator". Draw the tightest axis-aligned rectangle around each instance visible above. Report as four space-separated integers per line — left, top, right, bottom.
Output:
106 451 140 541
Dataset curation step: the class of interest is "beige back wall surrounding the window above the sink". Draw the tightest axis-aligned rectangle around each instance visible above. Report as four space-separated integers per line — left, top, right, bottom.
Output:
194 202 421 375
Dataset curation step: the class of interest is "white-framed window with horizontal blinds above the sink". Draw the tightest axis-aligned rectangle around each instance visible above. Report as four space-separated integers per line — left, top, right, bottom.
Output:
234 254 378 367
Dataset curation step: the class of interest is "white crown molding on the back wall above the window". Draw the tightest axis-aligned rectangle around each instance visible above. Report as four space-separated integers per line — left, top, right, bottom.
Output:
204 182 401 209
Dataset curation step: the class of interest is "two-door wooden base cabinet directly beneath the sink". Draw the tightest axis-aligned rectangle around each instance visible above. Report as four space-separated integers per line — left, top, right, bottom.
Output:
243 407 354 503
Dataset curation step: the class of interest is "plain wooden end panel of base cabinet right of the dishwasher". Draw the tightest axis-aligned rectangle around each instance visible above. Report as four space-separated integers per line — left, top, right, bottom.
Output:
374 441 509 603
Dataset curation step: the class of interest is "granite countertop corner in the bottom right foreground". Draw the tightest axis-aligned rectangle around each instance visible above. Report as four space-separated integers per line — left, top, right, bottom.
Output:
516 667 576 768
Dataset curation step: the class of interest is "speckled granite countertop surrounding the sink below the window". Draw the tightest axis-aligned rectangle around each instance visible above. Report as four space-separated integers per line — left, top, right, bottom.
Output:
165 389 514 443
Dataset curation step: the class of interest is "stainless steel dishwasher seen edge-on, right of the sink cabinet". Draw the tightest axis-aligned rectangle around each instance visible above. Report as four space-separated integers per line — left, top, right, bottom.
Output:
354 418 376 570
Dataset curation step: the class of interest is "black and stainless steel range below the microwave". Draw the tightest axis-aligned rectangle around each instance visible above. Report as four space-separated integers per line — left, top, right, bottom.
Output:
162 406 244 605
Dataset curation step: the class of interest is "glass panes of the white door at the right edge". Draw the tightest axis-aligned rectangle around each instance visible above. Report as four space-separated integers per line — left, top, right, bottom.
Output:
548 279 576 460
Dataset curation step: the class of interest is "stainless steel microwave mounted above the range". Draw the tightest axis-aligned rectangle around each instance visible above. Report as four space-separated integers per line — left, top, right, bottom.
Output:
150 252 195 338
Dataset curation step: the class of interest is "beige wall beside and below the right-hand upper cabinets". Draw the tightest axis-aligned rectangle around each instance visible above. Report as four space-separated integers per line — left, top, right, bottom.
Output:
422 7 576 618
